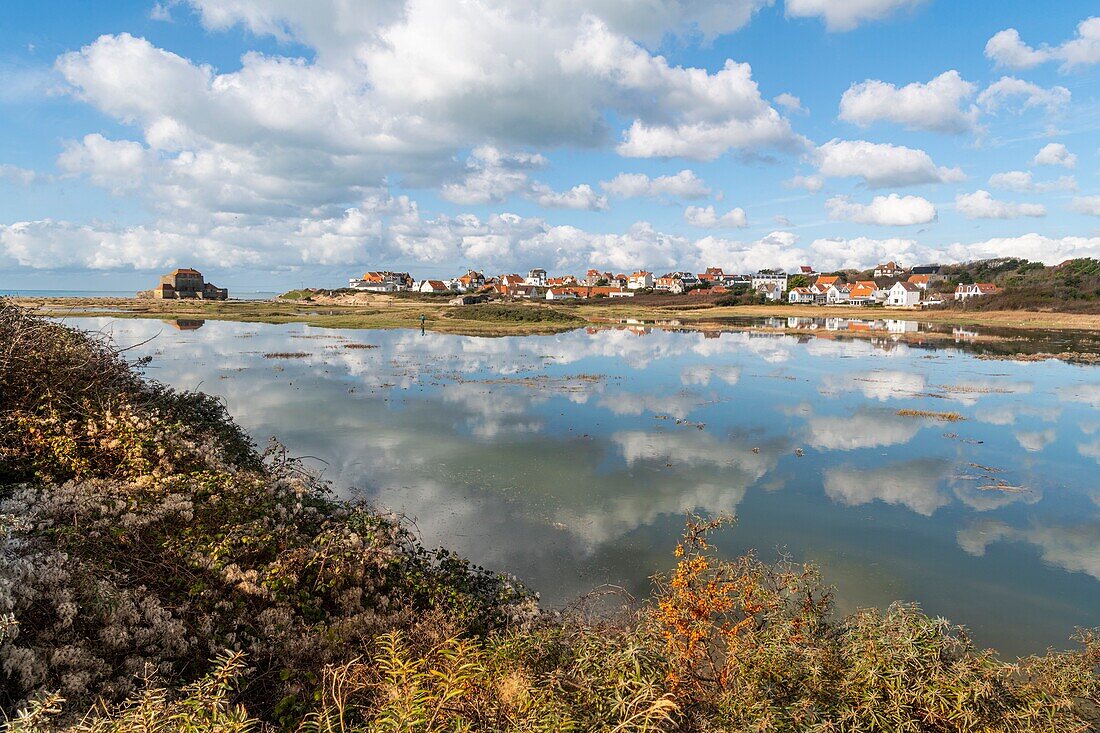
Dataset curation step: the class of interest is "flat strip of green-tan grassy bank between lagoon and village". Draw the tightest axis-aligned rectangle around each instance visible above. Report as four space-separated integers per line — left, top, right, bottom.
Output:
14 293 1100 336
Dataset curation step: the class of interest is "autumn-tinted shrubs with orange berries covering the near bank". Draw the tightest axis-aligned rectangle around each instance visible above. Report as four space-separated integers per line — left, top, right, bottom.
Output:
0 304 1100 732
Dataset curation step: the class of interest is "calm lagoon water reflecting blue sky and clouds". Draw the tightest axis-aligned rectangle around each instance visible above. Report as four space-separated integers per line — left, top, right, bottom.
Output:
68 319 1100 654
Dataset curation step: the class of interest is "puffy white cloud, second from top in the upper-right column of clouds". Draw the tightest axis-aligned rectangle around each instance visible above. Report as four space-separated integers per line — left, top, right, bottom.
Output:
840 69 978 133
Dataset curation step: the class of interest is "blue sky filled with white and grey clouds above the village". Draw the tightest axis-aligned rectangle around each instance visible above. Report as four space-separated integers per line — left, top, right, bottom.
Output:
0 0 1100 289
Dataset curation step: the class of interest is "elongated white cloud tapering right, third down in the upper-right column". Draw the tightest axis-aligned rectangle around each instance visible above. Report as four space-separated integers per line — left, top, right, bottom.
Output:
817 140 966 188
